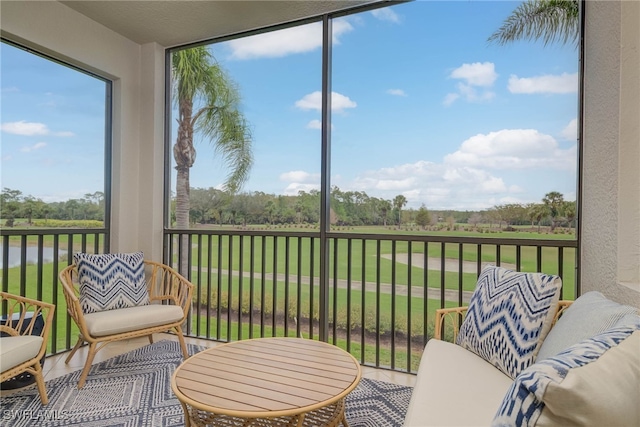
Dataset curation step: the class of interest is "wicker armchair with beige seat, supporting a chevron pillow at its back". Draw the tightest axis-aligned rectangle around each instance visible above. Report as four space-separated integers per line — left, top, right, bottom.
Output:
60 261 194 389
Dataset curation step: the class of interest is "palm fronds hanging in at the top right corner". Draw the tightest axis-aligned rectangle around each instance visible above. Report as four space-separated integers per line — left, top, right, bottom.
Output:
488 0 580 46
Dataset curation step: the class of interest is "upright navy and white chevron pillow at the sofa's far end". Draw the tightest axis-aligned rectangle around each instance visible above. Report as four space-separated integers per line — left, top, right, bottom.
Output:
456 265 562 378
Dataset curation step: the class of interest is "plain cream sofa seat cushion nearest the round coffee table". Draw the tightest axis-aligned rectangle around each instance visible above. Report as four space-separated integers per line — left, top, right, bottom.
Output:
404 339 513 427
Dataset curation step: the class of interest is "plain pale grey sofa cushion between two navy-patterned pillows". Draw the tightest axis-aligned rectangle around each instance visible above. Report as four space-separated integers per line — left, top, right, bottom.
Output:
536 291 638 360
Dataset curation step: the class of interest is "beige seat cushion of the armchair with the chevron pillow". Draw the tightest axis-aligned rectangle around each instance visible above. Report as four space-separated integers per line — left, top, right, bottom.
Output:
84 304 183 337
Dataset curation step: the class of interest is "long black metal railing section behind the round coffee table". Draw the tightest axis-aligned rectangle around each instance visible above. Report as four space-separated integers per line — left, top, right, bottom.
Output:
165 230 577 372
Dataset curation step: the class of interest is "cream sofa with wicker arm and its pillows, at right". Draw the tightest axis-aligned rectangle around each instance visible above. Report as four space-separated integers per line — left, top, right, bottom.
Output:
404 266 640 427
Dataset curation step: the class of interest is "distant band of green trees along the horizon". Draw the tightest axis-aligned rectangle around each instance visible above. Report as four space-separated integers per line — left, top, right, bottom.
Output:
0 186 576 231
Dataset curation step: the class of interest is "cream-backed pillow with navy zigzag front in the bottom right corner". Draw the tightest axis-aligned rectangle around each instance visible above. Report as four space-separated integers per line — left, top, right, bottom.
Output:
493 324 640 426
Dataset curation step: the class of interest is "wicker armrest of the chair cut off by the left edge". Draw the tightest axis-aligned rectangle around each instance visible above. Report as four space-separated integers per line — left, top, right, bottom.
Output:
0 292 56 358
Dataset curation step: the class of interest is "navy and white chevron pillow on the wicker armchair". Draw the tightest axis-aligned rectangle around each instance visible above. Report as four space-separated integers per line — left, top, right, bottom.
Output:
73 252 149 314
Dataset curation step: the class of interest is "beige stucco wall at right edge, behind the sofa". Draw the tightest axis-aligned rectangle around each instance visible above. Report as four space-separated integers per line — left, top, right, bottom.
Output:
581 1 640 307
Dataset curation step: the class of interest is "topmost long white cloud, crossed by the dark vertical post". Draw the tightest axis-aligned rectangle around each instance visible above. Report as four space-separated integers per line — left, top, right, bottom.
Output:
228 19 353 60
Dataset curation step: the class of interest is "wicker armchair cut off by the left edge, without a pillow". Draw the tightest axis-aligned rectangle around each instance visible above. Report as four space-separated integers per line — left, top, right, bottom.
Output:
0 292 55 405
